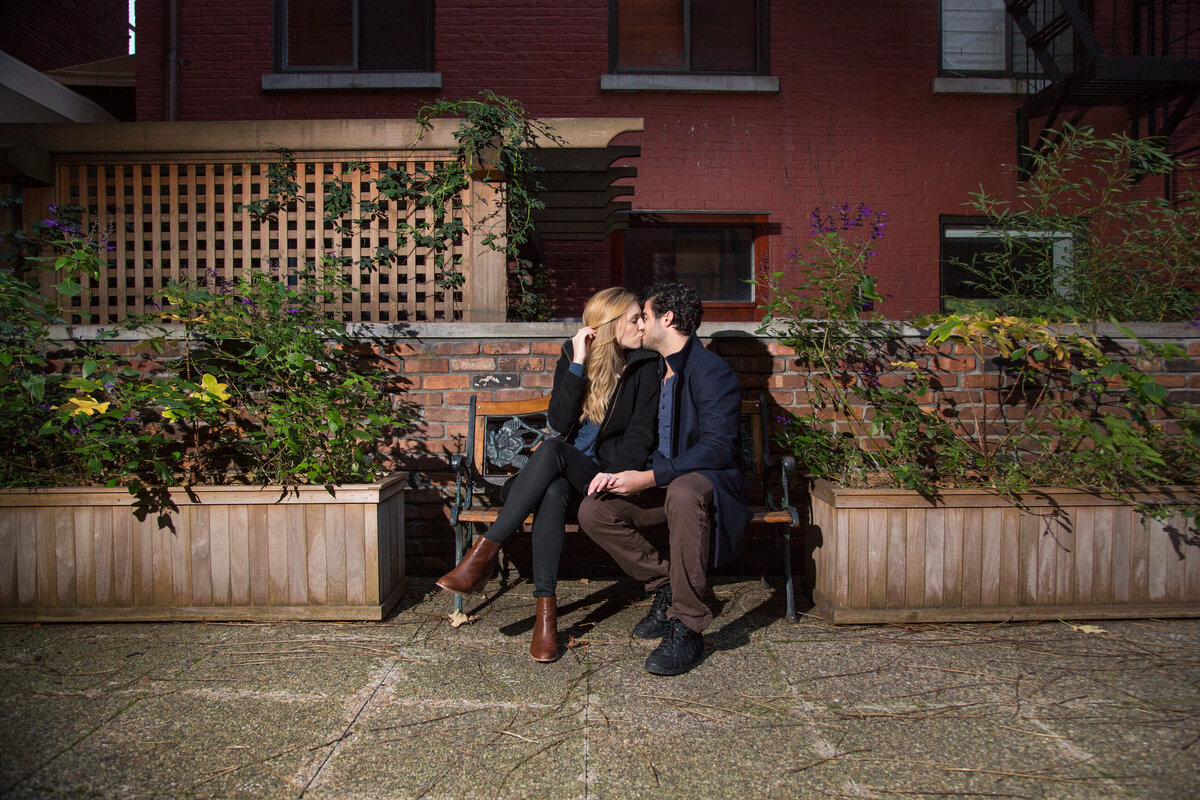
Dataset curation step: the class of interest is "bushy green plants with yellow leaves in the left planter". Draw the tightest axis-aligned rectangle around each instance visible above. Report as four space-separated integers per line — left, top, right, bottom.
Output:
0 211 410 525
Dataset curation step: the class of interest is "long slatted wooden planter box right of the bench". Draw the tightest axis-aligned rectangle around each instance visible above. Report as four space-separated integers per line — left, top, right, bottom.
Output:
809 481 1200 624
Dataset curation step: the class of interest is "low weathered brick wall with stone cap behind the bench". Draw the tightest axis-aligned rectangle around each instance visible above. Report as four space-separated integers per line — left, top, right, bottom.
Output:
46 323 1200 578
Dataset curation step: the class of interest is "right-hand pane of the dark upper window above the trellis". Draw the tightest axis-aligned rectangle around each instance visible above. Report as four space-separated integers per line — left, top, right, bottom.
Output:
359 0 433 71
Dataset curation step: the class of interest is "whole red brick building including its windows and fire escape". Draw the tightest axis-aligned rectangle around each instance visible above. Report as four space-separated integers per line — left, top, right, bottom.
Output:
114 0 1200 319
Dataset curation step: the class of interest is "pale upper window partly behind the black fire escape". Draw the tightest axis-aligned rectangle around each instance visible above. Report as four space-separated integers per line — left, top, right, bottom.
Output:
941 0 1072 78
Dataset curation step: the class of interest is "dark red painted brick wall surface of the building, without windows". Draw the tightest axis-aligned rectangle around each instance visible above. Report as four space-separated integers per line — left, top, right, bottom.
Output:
131 0 1046 315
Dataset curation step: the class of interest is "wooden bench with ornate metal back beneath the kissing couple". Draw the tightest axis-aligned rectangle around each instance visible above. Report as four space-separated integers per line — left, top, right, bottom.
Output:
450 395 800 622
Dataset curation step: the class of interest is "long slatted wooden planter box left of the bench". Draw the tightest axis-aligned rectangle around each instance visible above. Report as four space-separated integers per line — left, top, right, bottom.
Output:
0 475 407 621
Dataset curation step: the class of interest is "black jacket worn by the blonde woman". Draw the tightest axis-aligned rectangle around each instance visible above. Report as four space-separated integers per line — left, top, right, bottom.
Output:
546 339 661 473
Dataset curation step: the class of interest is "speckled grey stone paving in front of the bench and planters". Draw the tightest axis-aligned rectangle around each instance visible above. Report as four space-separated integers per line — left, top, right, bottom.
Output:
0 578 1200 800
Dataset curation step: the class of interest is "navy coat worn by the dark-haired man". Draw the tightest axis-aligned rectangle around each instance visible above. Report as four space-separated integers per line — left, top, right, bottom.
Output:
650 335 750 566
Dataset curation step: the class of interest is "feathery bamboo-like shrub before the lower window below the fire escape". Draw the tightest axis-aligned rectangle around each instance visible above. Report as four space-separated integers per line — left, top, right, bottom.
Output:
962 126 1200 321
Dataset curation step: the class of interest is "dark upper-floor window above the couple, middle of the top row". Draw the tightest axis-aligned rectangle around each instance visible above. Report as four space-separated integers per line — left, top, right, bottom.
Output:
608 0 767 74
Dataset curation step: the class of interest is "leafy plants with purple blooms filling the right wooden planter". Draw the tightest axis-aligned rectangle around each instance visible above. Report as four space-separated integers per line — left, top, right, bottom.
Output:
758 206 1200 522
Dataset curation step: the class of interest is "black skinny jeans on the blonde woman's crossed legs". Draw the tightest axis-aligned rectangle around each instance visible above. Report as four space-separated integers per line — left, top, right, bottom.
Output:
484 439 600 597
